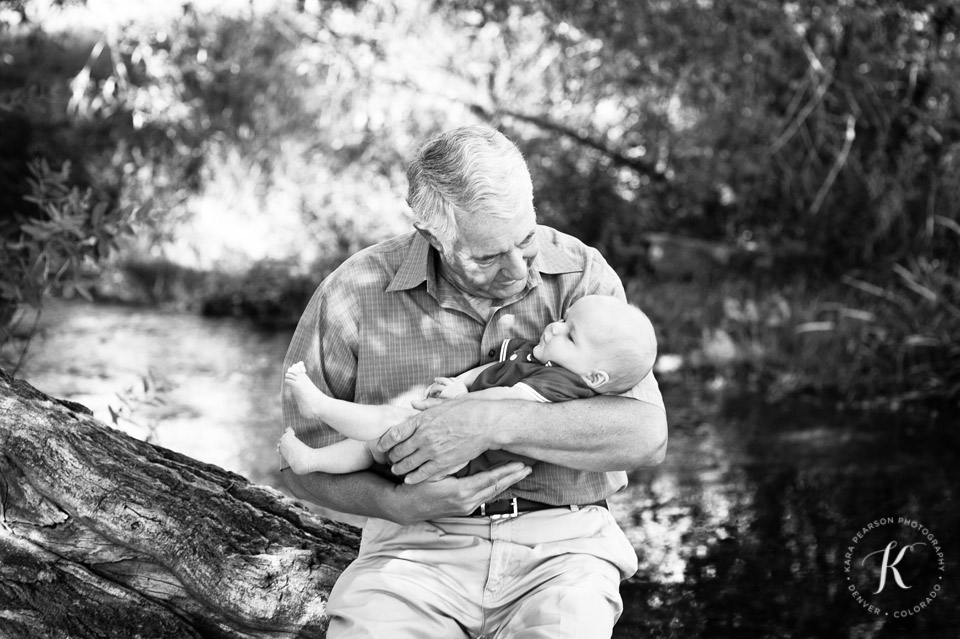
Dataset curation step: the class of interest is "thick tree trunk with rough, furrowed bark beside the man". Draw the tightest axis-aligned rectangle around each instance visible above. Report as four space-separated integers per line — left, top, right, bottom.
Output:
0 370 359 639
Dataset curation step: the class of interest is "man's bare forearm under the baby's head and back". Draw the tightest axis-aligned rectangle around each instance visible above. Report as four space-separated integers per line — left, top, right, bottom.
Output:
484 396 667 471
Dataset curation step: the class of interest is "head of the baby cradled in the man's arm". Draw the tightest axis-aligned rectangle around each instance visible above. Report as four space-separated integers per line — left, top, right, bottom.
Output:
533 295 657 393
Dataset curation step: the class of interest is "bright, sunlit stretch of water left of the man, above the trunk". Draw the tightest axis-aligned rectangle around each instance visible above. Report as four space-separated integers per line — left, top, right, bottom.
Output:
4 302 292 487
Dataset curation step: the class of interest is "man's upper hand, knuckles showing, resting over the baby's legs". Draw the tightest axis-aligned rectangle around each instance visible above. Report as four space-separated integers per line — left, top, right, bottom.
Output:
377 399 494 484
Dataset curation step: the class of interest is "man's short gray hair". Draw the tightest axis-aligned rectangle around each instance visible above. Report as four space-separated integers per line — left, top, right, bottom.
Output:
407 125 533 248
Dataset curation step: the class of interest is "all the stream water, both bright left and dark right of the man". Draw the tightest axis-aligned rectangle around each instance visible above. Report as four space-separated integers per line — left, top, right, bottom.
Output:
3 304 960 639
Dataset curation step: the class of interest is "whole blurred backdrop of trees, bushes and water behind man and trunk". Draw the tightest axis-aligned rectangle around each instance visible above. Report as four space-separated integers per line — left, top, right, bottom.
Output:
0 0 960 638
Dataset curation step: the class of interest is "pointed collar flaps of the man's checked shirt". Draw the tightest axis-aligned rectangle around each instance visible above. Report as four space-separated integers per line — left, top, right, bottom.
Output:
387 226 583 293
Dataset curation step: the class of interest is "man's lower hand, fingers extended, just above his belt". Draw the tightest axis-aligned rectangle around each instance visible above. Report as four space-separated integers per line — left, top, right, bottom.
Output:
389 462 531 525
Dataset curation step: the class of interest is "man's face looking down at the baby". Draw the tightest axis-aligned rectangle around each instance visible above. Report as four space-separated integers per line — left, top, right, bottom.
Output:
442 200 539 299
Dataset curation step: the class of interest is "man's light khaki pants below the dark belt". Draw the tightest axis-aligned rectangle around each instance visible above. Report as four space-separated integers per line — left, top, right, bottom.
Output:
327 506 637 639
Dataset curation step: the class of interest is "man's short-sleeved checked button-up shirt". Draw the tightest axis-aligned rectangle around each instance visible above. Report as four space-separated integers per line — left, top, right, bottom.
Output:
283 226 663 505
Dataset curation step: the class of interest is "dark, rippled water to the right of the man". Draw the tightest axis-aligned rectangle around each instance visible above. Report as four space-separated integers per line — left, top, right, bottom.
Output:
614 398 960 639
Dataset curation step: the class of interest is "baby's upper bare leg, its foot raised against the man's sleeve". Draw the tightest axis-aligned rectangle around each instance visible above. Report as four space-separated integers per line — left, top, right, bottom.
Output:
284 362 419 441
